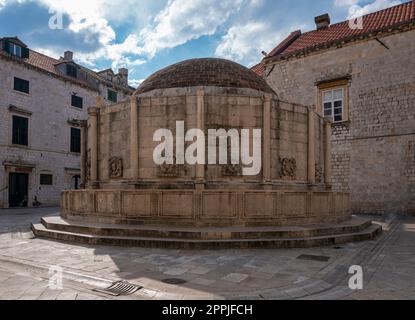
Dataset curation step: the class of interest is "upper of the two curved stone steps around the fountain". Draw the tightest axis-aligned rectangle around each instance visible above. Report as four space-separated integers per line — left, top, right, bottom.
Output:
41 217 372 240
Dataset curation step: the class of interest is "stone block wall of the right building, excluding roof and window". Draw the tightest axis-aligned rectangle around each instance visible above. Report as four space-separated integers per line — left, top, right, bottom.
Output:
265 30 415 214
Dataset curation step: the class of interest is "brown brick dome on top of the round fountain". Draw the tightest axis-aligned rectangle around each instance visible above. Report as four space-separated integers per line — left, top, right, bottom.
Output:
135 58 274 95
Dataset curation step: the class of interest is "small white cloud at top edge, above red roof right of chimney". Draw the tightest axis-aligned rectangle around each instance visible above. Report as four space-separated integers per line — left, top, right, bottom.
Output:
334 0 402 19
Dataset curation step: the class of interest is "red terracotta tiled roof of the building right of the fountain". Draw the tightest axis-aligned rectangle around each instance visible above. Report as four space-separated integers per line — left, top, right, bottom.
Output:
266 0 415 59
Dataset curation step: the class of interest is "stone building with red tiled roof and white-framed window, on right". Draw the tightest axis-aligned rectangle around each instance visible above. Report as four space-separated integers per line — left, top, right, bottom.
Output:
252 1 415 214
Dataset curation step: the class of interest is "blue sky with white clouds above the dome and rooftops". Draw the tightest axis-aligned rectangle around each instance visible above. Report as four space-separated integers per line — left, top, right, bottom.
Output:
0 0 407 87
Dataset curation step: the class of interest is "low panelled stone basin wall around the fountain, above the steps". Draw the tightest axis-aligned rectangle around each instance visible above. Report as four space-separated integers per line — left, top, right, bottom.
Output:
61 190 350 227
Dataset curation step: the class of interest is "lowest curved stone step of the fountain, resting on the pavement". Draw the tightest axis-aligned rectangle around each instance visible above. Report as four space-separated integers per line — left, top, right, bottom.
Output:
32 223 382 250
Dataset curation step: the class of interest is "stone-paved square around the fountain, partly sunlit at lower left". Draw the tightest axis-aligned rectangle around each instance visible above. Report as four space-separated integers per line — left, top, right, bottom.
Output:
0 208 415 300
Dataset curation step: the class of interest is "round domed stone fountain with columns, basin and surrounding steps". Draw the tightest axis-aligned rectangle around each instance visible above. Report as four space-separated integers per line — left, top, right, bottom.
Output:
32 59 380 248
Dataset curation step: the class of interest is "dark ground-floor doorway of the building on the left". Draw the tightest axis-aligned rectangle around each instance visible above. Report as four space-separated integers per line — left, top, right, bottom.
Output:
9 173 29 208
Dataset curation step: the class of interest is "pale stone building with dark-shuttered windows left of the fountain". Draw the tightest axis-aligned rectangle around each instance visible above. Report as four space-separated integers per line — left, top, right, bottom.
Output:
0 38 133 208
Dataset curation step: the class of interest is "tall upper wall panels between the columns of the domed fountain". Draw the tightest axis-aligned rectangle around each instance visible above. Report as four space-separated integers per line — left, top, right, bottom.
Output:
89 87 324 188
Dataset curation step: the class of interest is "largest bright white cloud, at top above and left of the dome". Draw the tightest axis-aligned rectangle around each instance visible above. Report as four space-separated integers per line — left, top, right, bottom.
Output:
35 0 247 69
